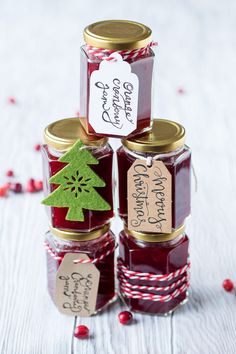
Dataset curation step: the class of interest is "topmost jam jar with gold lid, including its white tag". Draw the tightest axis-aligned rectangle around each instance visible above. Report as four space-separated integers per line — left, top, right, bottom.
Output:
80 20 155 137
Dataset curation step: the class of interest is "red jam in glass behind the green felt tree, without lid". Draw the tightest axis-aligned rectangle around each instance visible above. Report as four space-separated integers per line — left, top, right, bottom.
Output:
42 145 113 232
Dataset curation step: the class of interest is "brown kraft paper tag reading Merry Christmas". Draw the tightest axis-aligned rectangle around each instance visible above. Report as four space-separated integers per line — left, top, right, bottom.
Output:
127 160 172 233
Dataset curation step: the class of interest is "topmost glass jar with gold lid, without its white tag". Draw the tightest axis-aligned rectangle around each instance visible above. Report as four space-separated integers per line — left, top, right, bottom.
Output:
80 20 154 137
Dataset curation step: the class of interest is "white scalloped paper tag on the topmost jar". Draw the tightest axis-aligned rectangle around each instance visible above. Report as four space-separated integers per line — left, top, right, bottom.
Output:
89 53 139 136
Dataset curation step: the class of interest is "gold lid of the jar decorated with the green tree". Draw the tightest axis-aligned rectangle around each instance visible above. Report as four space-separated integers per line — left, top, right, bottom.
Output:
44 118 108 151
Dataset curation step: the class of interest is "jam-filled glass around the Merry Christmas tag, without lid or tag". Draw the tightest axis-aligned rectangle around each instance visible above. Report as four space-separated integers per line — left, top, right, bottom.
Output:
117 146 191 229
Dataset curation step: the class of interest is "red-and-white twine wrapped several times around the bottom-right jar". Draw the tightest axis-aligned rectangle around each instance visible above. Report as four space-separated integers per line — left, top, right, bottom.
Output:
118 259 190 302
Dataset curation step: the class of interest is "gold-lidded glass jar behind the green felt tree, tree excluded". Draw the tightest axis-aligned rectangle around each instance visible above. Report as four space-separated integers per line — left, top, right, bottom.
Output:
42 118 113 232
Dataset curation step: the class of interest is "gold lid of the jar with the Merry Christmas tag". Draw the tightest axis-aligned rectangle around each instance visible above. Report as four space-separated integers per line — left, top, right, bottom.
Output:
122 119 185 153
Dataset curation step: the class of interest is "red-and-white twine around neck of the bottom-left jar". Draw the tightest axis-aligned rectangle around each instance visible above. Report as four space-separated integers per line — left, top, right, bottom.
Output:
44 239 116 264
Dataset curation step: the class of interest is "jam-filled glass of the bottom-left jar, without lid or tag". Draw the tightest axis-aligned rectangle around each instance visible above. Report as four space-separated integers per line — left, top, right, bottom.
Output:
46 231 115 310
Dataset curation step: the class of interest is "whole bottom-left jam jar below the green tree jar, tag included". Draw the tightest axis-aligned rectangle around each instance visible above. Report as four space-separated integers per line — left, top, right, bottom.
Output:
45 224 115 315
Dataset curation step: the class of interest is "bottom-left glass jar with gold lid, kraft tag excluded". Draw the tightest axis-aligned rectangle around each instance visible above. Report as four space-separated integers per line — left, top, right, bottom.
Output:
45 225 115 312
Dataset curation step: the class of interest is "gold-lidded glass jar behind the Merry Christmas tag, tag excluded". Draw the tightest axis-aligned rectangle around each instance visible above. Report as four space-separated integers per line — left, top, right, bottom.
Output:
117 119 191 231
